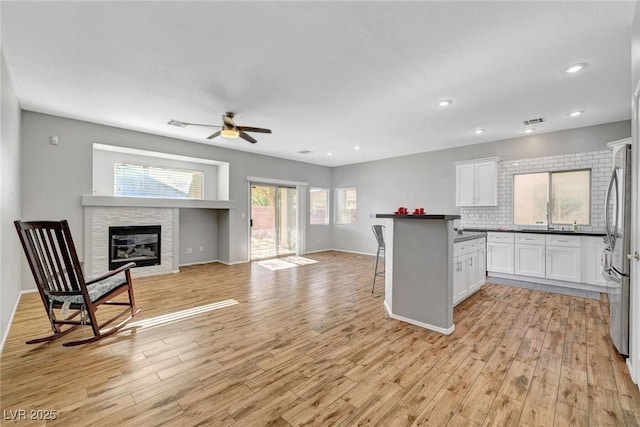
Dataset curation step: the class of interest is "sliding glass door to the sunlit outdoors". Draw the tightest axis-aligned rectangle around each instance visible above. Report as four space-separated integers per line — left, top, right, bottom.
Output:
251 183 298 260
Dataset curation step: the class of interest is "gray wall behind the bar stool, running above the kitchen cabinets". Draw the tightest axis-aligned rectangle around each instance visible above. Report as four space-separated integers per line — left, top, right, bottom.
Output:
332 120 631 253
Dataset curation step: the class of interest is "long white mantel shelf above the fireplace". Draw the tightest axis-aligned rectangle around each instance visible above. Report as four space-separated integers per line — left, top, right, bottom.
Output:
82 196 235 209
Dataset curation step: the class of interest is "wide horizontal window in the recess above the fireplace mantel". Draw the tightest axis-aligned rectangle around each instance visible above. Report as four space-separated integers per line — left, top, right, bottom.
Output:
113 162 204 199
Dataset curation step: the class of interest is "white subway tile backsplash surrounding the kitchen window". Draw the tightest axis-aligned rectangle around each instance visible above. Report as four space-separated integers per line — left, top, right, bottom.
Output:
460 150 611 233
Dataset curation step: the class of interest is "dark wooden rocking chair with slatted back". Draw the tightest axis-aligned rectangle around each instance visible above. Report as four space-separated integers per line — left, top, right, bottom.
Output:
14 220 140 346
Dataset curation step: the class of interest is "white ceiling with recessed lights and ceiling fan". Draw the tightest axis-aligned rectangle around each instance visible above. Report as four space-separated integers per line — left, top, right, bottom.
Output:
1 1 635 166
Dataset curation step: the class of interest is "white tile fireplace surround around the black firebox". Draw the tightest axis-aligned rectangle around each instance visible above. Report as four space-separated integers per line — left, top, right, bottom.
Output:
84 206 178 277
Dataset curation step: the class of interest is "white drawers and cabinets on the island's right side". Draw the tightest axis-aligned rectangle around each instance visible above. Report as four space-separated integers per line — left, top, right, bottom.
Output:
453 237 487 305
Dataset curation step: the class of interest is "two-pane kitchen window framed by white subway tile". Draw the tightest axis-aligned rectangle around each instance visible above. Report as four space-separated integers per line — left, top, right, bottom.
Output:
513 169 591 225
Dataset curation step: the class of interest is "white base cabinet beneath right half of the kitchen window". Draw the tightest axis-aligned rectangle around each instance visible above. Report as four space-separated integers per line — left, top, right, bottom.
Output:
546 235 581 282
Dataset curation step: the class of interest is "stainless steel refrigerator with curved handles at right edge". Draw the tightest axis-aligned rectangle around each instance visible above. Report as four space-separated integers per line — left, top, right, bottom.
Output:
602 144 631 355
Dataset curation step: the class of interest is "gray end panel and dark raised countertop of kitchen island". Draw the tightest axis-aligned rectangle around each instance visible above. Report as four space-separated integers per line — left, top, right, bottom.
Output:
376 214 460 335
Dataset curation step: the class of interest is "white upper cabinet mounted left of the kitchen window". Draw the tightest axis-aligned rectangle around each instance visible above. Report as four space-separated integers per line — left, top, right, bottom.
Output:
455 157 500 206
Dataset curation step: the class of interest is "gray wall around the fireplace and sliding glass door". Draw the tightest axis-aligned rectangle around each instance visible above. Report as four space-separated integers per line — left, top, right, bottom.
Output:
22 111 331 274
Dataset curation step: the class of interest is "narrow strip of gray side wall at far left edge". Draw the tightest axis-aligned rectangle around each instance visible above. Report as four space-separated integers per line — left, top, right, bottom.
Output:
0 50 23 347
